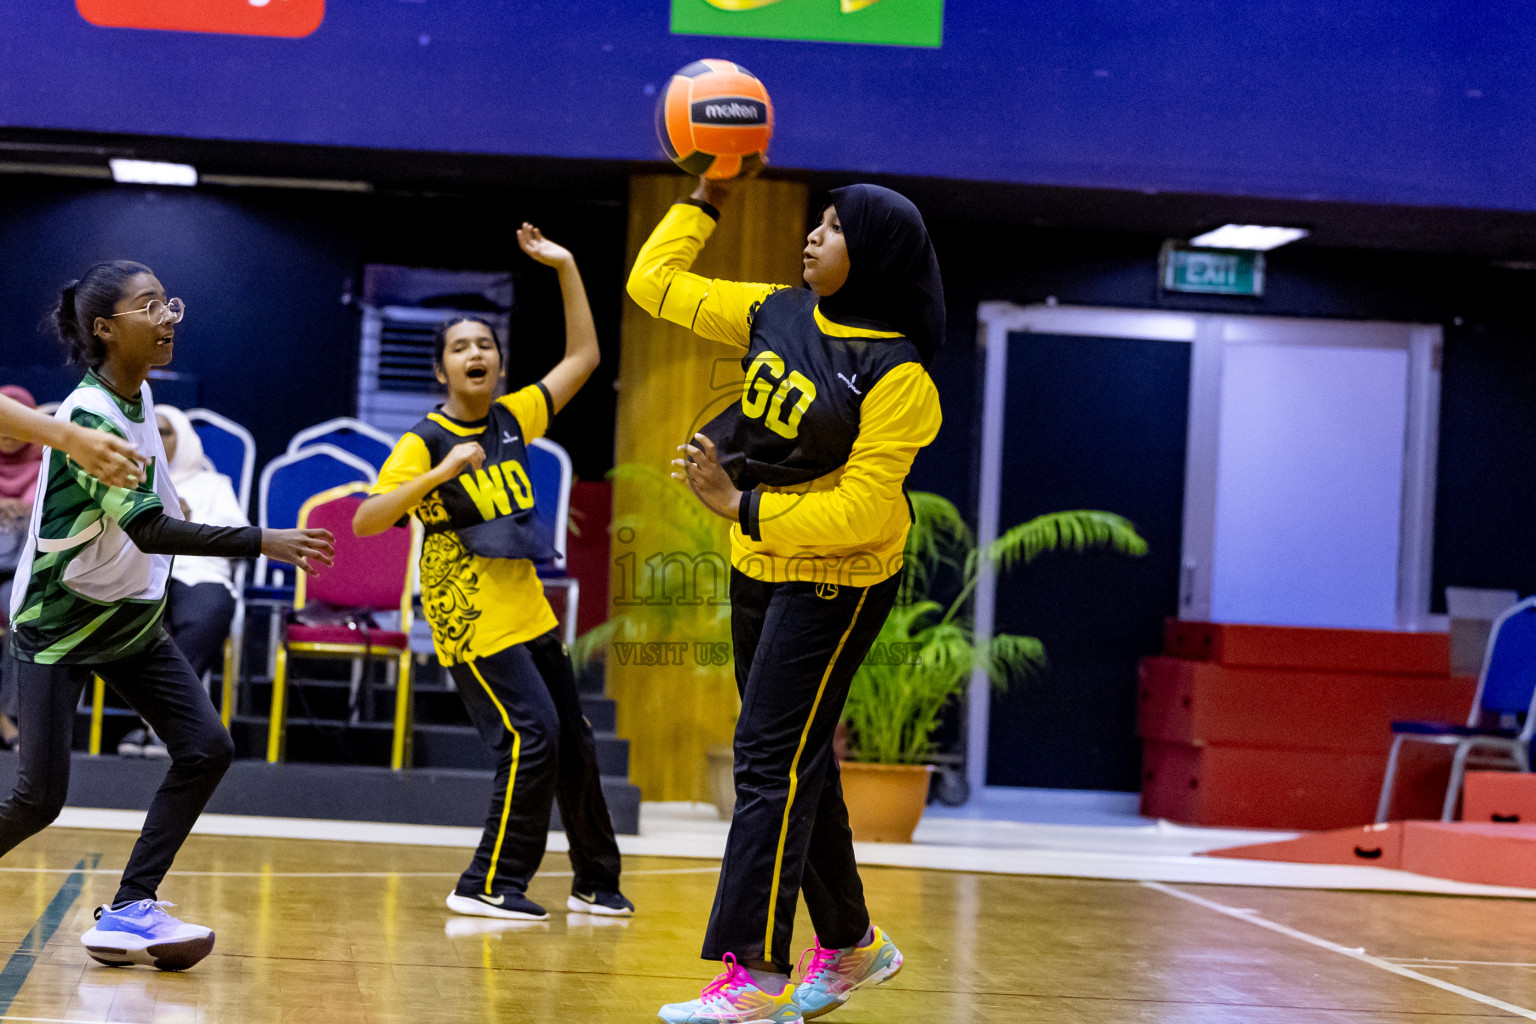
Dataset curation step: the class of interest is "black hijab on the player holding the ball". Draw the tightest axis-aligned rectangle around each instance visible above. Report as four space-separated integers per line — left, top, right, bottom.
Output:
820 184 945 365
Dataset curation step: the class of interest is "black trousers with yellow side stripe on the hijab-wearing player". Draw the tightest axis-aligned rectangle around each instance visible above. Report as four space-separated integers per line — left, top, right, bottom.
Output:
703 570 902 973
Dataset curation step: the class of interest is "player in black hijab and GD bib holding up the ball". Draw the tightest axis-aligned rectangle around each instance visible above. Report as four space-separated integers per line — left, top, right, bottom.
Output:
628 180 945 1024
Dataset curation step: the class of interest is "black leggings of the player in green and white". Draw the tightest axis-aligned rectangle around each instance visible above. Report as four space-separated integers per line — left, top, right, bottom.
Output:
0 634 235 904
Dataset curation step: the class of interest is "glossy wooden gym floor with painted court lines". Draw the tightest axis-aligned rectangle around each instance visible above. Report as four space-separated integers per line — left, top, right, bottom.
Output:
0 829 1536 1024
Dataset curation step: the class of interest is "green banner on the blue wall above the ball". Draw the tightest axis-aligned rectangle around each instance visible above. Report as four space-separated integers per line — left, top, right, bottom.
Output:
671 0 945 46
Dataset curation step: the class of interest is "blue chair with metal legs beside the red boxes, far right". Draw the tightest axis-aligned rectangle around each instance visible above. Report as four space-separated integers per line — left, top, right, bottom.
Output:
1376 597 1536 821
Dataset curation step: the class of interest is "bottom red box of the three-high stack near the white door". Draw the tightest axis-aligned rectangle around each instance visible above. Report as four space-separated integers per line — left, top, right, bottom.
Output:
1141 740 1450 831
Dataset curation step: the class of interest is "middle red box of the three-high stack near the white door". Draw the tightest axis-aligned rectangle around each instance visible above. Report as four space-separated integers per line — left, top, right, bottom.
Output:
1137 657 1476 752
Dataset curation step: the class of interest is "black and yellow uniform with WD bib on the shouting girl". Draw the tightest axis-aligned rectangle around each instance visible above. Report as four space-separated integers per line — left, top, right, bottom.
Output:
373 384 619 897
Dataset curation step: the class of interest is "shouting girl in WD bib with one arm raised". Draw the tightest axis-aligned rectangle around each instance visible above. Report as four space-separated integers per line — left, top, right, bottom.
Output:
352 224 634 921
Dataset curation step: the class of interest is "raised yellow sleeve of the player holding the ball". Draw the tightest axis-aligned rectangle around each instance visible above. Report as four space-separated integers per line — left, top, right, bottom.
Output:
628 203 783 348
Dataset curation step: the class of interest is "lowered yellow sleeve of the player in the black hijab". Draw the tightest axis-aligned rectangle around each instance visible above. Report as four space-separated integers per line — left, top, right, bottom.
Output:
742 362 943 551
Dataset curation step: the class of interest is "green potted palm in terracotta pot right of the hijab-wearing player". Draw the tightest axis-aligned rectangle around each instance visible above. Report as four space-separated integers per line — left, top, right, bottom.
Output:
842 491 1146 843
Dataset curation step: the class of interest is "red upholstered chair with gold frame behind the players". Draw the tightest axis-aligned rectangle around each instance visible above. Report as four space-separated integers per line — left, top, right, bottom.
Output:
267 482 418 771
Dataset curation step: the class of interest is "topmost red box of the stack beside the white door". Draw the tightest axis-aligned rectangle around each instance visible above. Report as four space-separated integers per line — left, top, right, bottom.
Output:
1163 619 1450 676
